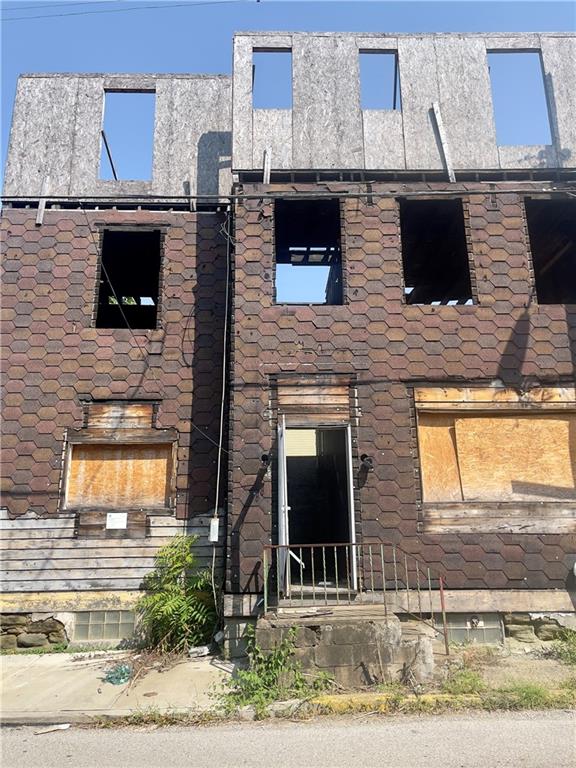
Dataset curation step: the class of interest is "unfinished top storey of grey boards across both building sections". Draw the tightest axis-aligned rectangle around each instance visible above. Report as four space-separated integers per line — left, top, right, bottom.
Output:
4 32 576 198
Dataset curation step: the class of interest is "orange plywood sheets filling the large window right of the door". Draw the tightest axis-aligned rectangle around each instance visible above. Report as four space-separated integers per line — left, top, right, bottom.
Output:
418 411 576 502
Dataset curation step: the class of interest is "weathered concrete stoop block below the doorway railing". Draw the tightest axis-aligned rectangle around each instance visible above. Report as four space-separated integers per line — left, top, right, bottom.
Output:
256 615 434 688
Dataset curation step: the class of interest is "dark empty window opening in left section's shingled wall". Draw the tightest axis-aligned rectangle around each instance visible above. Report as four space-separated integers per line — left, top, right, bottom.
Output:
96 229 161 328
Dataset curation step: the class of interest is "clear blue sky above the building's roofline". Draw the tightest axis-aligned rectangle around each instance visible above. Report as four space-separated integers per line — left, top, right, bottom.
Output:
0 0 576 178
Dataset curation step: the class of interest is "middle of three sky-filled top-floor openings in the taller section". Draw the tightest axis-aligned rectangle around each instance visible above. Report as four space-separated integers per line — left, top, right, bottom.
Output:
359 51 401 110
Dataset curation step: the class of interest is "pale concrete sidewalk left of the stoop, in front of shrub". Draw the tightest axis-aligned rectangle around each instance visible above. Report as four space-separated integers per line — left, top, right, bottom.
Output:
0 651 233 725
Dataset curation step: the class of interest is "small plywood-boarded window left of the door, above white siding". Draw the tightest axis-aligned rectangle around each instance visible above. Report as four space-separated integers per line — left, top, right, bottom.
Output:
66 443 172 509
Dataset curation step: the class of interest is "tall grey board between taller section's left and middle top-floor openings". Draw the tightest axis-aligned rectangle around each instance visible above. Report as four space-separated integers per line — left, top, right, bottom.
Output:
292 35 364 169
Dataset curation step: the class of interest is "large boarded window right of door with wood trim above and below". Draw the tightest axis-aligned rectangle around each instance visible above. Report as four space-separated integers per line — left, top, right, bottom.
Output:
416 388 576 533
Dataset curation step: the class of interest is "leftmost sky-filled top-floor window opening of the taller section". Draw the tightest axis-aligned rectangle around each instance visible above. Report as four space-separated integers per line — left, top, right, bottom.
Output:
252 50 292 109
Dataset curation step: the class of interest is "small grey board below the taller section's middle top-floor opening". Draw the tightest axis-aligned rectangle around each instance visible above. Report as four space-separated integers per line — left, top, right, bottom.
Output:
362 109 406 170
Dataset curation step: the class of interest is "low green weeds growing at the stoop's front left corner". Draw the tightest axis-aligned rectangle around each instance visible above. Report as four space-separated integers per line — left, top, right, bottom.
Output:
221 627 332 718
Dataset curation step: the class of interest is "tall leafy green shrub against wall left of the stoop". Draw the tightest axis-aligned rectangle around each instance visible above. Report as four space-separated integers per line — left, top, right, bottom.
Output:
136 536 217 653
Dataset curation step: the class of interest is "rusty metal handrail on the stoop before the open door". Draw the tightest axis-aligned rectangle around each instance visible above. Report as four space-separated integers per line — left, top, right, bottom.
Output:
262 539 449 655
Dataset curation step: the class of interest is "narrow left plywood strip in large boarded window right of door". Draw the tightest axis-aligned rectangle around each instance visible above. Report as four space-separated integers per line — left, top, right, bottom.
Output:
418 413 462 502
